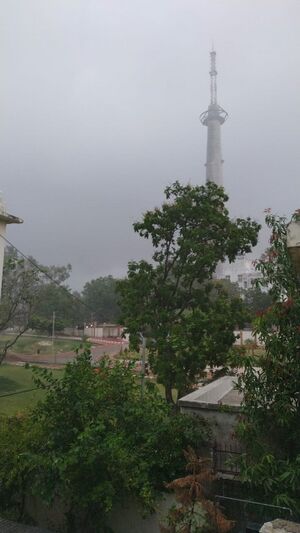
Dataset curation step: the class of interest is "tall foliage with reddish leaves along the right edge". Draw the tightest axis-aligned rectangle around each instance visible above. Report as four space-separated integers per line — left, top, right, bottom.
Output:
239 210 300 511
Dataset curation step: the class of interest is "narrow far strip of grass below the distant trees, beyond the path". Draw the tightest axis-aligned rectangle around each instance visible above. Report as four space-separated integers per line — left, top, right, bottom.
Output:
0 335 81 355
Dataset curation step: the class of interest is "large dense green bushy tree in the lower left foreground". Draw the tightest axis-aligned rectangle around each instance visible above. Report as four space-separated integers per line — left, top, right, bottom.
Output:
0 349 208 532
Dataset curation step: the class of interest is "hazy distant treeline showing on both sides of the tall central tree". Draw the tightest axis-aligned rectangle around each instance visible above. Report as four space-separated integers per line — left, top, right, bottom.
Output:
3 243 271 334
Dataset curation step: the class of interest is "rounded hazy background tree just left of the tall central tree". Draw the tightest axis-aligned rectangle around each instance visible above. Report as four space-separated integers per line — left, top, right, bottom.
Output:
82 276 120 323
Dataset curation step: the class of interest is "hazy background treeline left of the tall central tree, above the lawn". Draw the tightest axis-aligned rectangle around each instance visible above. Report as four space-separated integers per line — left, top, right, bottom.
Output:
2 247 120 334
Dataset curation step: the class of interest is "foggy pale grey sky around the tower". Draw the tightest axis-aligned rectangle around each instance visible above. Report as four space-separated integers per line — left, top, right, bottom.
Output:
0 0 300 288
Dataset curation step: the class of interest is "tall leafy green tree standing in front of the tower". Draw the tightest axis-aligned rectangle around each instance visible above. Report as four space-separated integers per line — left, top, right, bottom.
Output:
118 182 259 402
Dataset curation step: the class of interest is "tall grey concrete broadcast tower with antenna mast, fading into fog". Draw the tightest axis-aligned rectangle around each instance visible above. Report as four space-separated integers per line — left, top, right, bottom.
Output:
199 49 228 186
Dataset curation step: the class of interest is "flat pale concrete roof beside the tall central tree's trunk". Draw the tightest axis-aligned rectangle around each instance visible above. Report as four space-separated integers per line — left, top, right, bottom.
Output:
178 376 242 411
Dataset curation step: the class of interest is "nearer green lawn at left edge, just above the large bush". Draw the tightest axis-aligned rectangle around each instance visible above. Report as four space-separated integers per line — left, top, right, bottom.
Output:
0 364 63 416
